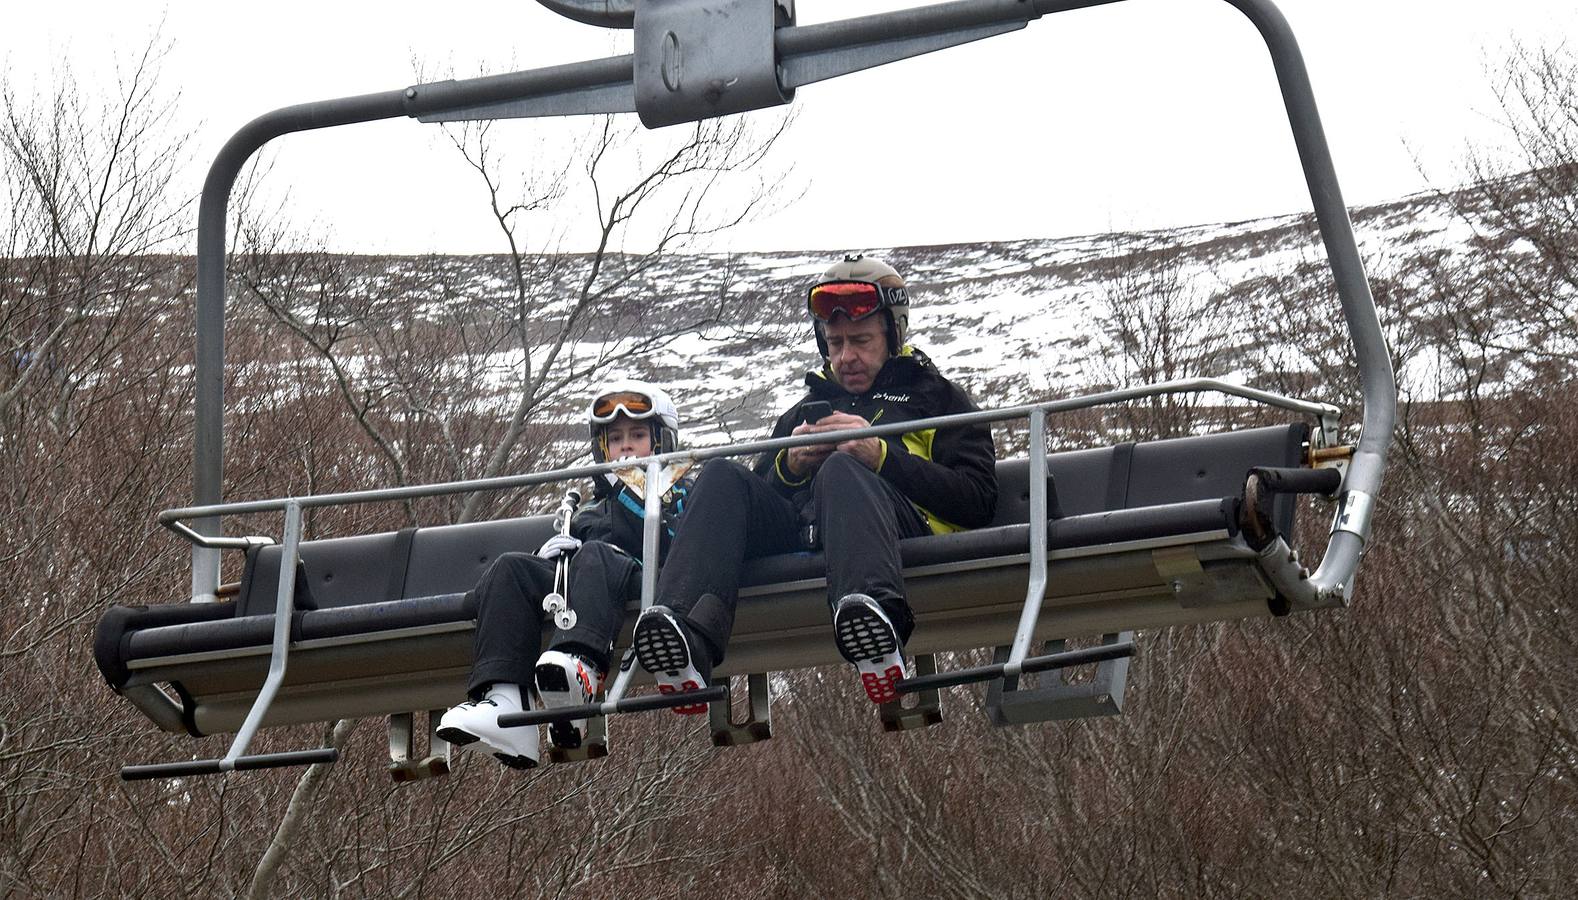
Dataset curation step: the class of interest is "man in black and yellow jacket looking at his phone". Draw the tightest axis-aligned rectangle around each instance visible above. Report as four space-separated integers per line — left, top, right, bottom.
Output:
634 256 997 714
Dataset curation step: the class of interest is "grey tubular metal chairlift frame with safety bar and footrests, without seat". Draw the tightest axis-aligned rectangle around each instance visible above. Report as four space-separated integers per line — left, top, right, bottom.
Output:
123 0 1397 777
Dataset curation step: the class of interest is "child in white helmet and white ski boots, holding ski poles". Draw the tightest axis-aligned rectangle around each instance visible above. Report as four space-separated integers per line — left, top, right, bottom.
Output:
437 381 690 769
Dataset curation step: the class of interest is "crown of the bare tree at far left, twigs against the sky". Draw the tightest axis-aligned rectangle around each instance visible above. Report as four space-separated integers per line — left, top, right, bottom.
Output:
0 38 189 428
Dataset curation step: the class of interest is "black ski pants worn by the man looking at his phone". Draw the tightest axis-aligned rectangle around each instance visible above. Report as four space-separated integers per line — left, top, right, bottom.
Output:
656 453 931 663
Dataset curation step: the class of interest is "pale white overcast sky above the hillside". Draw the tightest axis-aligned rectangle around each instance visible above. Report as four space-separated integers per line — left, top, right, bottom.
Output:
0 0 1578 253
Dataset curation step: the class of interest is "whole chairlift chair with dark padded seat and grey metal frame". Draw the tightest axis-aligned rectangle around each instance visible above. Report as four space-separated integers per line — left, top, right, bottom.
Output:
95 0 1397 780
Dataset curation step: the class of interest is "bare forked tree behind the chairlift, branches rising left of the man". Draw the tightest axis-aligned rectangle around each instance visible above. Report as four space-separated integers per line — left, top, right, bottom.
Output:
217 105 795 895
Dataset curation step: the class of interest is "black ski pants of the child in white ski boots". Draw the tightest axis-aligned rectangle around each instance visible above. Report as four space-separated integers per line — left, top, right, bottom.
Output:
467 540 641 699
